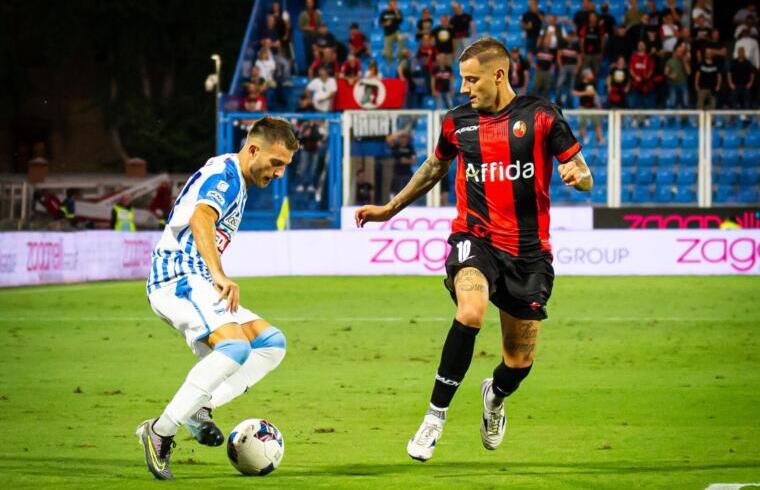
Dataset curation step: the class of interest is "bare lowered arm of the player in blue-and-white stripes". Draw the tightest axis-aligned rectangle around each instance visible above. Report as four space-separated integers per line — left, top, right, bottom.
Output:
190 204 240 313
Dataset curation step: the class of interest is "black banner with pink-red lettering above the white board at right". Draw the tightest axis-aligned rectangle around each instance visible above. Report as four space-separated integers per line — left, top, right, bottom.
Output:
594 206 760 230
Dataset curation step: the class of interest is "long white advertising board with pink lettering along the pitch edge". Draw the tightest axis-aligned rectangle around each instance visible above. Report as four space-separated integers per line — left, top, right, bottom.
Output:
0 230 760 286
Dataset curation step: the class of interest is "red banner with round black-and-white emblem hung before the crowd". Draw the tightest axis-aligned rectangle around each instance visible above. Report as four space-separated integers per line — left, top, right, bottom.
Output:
335 78 406 110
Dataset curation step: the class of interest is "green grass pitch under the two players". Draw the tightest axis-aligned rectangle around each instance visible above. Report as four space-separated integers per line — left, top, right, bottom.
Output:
0 277 760 490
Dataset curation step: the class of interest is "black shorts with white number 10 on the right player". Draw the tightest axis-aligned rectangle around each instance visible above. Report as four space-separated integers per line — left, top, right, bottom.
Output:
444 233 554 320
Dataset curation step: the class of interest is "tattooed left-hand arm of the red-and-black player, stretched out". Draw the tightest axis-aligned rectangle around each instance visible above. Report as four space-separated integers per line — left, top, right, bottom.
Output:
354 154 451 228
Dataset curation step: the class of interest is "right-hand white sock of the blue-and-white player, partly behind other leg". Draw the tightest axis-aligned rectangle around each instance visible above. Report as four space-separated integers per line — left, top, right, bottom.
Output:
207 347 285 409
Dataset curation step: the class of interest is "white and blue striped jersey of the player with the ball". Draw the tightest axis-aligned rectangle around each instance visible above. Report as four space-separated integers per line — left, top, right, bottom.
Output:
147 153 247 294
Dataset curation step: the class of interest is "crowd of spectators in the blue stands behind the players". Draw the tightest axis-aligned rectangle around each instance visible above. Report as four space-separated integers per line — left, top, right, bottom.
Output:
242 0 760 112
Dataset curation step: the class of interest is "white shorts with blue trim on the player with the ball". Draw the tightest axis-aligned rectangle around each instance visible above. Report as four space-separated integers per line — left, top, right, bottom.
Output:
148 274 261 357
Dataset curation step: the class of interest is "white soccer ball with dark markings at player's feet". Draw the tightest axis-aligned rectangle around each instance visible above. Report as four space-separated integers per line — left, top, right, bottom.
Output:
227 419 285 476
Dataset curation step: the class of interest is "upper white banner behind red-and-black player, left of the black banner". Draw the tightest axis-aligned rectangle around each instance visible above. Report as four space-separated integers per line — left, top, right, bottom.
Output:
340 206 594 231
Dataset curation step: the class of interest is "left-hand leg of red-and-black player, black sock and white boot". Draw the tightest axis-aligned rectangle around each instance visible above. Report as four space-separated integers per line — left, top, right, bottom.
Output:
407 262 489 461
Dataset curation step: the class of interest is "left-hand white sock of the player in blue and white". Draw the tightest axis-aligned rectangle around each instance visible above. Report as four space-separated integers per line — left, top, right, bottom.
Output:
153 351 242 437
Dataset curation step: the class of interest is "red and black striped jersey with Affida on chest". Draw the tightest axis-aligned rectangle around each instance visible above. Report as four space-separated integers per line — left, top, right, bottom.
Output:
435 96 581 256
